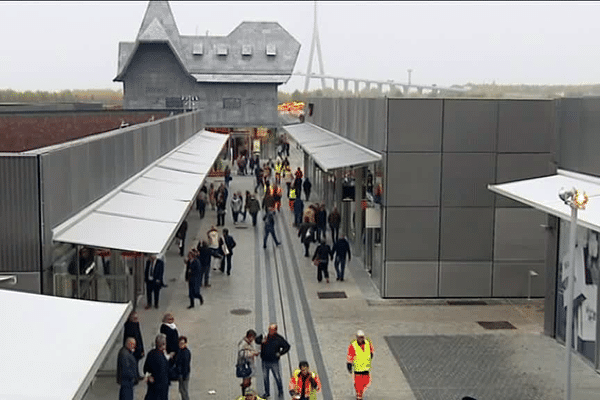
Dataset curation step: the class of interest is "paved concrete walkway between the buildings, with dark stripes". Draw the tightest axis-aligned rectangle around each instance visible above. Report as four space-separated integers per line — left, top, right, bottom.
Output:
86 146 600 400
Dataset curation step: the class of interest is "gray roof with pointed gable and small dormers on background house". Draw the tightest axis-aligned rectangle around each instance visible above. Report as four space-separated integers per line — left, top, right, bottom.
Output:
114 0 300 84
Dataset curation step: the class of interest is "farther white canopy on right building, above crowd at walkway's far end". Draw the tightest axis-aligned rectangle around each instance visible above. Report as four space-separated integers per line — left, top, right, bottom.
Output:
283 122 382 172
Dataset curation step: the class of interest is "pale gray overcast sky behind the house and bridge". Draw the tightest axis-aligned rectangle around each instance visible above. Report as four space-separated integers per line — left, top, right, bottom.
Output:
0 1 600 91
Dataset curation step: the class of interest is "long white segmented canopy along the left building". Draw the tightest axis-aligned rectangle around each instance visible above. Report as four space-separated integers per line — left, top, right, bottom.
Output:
52 131 228 254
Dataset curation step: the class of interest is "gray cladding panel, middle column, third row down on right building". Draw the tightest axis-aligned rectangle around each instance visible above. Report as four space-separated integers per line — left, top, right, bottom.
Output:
440 207 494 261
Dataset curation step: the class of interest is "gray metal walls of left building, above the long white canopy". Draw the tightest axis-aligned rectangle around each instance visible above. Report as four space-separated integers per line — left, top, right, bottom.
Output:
0 112 203 293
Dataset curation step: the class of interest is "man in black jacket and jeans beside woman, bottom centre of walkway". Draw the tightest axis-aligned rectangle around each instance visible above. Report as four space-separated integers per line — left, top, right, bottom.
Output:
255 324 290 398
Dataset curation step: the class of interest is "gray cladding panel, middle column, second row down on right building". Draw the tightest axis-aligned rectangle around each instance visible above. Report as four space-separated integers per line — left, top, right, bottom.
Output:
442 153 496 207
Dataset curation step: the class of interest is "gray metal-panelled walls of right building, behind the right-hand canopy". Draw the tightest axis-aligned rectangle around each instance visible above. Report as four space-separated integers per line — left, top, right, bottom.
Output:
309 98 556 297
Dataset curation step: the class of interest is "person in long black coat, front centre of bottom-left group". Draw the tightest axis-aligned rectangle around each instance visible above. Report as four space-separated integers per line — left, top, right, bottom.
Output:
144 333 170 400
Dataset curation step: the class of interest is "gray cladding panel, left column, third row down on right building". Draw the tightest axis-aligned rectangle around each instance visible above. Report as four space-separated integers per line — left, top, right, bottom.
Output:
386 207 439 261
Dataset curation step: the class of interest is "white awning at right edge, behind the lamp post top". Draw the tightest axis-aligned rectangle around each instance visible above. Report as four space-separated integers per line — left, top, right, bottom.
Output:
488 170 600 231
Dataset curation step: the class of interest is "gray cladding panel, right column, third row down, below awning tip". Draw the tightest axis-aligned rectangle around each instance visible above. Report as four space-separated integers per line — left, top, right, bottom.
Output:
494 208 547 261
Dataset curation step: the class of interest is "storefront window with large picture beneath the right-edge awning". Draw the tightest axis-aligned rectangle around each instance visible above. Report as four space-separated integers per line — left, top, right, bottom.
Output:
556 219 600 362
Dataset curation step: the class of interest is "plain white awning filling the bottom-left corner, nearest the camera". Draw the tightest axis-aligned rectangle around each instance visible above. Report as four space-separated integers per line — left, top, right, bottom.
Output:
0 290 132 400
